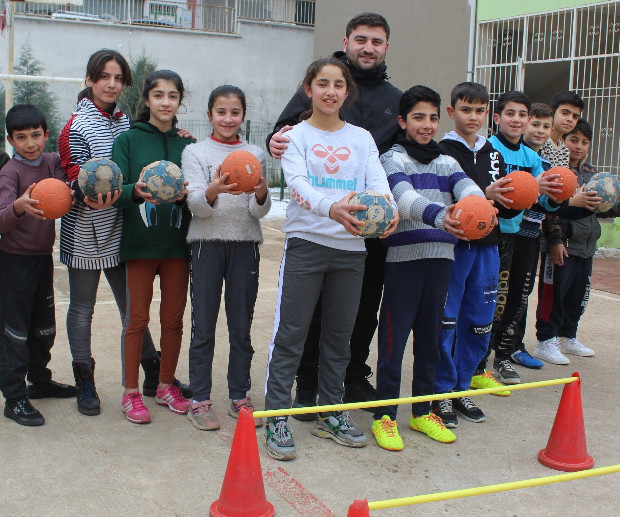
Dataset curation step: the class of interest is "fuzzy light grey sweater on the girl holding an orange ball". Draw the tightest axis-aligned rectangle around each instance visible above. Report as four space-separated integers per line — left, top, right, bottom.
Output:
181 138 271 243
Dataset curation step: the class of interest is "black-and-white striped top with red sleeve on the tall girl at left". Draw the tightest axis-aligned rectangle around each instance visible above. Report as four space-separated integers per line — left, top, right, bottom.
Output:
58 98 129 269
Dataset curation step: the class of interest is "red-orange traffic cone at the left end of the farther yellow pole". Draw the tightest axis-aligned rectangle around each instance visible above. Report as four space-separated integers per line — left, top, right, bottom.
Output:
210 408 274 517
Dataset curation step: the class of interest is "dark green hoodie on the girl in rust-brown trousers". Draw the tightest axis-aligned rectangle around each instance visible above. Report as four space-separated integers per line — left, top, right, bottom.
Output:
112 122 191 262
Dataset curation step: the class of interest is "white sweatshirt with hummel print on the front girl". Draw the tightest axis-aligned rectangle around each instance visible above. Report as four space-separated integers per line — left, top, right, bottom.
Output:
282 121 390 251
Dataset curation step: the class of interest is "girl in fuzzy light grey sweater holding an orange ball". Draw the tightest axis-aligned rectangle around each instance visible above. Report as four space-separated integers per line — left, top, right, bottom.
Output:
182 85 271 430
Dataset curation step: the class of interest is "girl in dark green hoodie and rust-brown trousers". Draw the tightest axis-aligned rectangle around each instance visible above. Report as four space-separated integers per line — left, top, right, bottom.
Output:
112 70 192 424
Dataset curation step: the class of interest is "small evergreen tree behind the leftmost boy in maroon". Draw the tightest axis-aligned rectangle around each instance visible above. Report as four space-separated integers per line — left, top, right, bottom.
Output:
12 41 61 152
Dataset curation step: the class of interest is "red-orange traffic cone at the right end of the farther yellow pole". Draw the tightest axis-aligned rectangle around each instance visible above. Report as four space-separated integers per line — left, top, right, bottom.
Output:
538 372 594 472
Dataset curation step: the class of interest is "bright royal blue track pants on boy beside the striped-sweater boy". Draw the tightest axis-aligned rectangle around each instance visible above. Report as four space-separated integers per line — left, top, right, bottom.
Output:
435 241 499 393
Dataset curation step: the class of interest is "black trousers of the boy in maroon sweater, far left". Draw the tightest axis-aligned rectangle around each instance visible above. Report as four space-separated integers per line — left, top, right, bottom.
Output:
0 251 56 401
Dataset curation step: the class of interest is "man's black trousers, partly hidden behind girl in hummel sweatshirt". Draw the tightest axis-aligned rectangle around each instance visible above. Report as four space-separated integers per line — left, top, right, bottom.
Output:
297 239 387 393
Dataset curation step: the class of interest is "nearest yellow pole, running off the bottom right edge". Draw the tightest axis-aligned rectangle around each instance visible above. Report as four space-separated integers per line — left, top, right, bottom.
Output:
368 465 620 510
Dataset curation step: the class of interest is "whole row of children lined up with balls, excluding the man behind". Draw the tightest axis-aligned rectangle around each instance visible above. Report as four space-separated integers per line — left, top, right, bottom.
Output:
0 50 618 460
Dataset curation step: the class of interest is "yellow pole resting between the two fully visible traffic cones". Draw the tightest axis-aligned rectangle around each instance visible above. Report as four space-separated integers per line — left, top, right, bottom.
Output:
254 377 579 418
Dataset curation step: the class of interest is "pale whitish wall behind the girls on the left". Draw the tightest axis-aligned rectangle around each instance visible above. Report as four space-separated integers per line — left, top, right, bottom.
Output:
0 17 314 122
